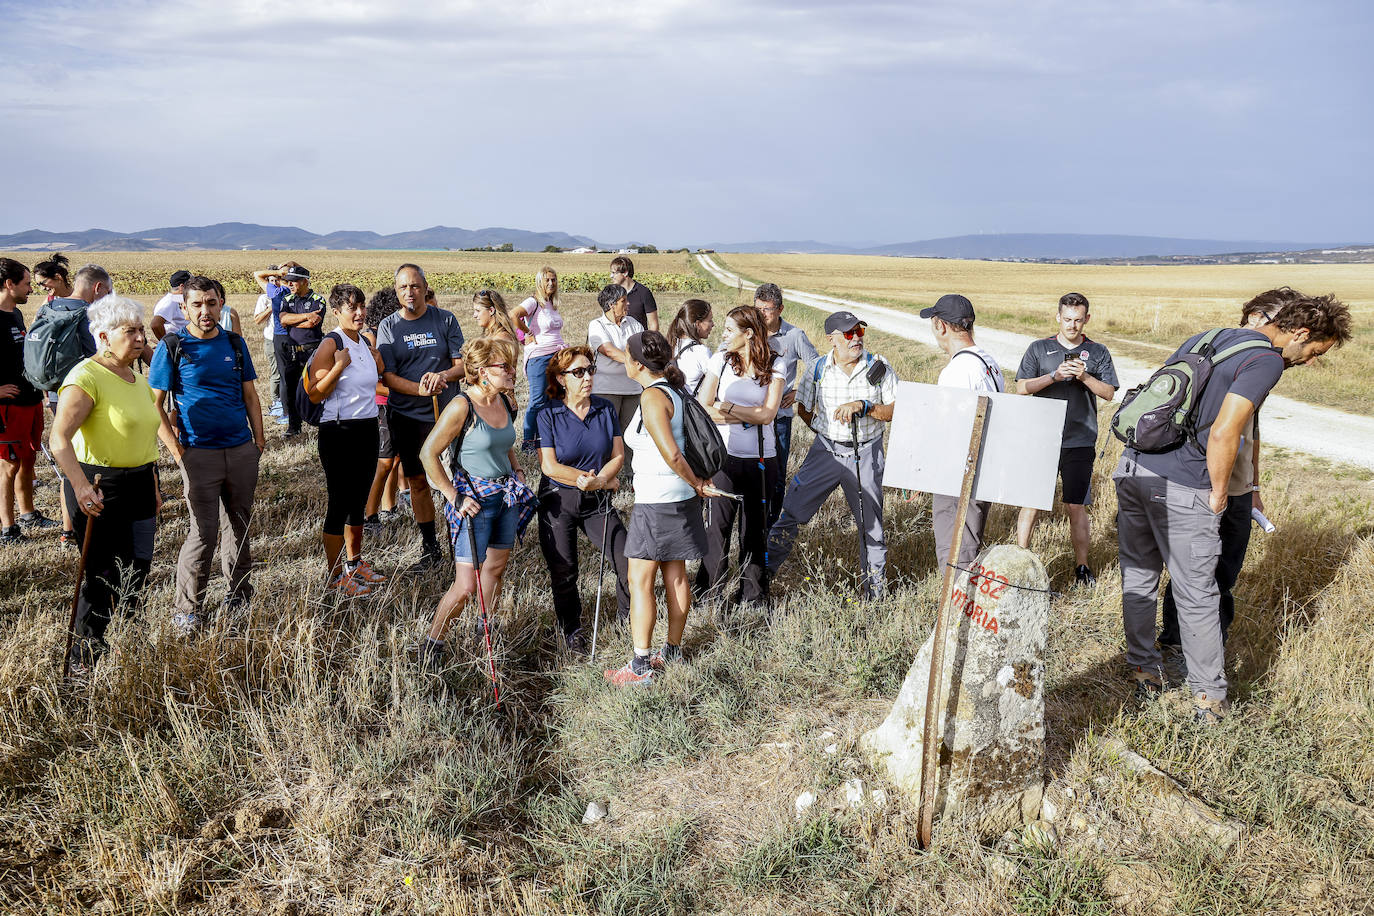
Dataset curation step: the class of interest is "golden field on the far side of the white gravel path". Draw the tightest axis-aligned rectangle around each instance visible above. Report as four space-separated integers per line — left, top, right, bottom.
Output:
714 248 1374 413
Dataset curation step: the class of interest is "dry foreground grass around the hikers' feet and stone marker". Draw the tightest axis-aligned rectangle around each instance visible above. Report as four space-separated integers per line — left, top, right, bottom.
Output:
0 276 1374 916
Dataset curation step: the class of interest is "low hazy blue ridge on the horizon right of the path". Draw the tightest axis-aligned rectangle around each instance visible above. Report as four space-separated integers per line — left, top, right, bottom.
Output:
709 232 1348 260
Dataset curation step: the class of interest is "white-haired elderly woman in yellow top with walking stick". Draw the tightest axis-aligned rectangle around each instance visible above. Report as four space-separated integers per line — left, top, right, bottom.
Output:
48 294 176 673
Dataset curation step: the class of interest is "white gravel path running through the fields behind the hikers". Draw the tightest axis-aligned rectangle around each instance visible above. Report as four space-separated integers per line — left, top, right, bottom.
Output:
697 254 1374 470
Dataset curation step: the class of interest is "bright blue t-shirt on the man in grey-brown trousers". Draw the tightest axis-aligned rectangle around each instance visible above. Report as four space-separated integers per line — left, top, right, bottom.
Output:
148 330 257 449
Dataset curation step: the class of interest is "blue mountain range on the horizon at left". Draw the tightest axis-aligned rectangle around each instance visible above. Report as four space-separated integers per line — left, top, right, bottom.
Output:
0 222 596 251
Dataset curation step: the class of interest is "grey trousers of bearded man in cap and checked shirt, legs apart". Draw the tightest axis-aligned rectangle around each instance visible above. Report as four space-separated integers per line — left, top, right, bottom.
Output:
768 435 888 595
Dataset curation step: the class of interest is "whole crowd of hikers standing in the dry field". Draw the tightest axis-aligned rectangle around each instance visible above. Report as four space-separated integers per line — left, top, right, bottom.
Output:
0 257 1351 721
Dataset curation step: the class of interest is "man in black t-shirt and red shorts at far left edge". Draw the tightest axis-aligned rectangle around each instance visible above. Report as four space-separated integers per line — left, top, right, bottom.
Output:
0 258 58 544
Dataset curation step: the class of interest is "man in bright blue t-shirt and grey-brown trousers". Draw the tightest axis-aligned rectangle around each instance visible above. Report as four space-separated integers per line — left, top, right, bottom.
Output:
148 276 265 636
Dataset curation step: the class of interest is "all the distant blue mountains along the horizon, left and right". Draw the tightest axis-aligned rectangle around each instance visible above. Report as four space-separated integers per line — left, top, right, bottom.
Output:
0 222 1348 260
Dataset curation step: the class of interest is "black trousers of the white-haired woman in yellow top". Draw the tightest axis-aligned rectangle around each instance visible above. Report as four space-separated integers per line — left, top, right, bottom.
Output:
62 464 158 643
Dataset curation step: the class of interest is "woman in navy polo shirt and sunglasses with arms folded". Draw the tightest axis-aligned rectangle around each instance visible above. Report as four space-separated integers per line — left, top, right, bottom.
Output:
536 346 629 654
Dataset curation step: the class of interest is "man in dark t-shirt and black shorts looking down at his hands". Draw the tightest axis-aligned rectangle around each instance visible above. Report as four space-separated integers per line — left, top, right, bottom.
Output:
1017 293 1118 585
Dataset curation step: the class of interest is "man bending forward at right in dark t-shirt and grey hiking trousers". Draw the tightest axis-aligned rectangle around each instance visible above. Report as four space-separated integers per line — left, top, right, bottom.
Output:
1112 297 1351 724
